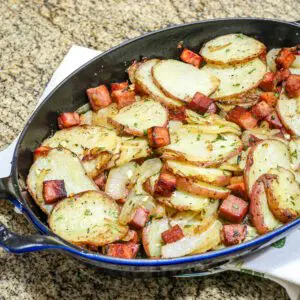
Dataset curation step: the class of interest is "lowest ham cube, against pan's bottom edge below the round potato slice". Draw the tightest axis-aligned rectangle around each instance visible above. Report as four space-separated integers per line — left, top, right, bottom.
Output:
105 242 140 259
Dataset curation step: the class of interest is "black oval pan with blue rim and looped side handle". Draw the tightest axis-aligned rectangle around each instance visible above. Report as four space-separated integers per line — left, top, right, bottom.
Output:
0 19 300 274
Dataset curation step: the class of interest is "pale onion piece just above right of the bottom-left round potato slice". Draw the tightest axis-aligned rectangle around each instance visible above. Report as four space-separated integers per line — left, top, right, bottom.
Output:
105 162 139 200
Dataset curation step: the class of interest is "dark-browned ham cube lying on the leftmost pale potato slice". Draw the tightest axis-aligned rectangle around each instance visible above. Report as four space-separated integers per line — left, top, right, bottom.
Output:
43 180 67 204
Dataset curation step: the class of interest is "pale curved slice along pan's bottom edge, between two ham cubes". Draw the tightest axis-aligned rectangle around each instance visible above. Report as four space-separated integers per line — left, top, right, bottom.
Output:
161 220 222 258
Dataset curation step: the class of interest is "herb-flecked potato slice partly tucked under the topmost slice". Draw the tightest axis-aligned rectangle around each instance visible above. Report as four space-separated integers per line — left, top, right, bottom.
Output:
202 58 266 101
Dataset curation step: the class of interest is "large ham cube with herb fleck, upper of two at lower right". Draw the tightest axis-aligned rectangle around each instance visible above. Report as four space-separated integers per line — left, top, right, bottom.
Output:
219 195 248 223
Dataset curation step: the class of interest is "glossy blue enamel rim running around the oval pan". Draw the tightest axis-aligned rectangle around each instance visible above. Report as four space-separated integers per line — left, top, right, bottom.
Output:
7 18 300 267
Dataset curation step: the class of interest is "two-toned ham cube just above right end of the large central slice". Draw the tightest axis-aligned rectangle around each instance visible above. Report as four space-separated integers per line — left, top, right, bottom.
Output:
227 106 258 129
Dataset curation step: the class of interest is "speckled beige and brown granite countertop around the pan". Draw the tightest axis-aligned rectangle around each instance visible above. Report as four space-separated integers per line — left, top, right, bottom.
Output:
0 0 300 300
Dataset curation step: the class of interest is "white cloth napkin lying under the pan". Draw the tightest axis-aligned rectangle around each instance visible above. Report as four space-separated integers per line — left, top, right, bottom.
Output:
0 45 300 300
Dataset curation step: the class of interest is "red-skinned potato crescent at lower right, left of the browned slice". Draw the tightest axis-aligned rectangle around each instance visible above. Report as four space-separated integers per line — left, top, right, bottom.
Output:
249 175 282 234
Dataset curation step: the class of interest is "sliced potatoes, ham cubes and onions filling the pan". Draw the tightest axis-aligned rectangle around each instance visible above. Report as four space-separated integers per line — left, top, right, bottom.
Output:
27 33 300 259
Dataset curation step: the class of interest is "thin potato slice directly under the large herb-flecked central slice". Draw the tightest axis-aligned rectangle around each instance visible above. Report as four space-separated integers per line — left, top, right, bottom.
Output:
165 160 231 186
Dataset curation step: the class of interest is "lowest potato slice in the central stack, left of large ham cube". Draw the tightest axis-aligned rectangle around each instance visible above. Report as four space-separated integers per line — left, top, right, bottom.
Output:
157 190 218 212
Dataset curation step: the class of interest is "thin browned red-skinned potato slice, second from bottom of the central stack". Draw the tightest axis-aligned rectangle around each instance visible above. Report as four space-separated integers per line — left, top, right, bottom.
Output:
176 177 230 199
